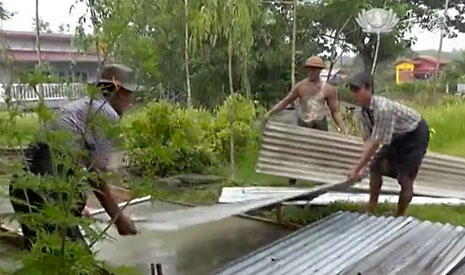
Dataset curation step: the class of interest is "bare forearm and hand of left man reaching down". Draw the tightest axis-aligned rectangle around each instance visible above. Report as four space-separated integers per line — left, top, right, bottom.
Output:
89 179 137 235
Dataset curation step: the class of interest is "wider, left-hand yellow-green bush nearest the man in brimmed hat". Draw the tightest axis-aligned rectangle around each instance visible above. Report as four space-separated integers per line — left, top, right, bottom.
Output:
125 101 214 176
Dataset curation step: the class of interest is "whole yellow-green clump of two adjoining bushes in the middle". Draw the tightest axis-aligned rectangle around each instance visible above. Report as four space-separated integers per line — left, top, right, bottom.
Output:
125 94 258 176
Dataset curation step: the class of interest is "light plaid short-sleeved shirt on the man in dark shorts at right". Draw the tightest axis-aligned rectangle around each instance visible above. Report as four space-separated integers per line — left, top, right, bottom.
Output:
358 96 422 144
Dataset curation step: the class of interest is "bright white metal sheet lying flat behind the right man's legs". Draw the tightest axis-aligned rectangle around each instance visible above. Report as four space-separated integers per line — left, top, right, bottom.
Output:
218 187 465 205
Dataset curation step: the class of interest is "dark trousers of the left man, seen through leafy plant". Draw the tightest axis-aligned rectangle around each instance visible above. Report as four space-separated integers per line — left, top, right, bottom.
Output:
9 143 86 249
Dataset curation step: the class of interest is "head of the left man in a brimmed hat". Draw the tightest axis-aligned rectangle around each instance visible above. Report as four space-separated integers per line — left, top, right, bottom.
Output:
97 64 136 115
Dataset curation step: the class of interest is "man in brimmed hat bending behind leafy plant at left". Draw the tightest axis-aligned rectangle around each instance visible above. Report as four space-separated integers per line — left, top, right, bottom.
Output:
10 64 137 248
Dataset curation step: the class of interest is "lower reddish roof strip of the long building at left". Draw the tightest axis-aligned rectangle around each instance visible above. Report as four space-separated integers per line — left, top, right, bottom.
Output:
8 50 98 62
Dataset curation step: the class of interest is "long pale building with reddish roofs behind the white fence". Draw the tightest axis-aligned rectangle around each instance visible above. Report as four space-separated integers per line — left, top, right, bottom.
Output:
0 31 98 83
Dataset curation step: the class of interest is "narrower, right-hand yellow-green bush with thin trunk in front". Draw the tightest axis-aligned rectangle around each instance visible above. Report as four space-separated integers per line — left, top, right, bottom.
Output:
213 94 257 161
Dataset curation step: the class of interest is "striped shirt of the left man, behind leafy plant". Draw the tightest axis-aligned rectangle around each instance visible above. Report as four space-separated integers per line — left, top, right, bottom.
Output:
57 99 120 171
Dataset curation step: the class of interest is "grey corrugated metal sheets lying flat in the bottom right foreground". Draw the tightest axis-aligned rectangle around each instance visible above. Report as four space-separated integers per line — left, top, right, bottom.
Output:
216 212 465 275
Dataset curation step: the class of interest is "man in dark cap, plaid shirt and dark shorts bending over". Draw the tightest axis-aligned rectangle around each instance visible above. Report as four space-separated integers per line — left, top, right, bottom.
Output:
347 72 429 216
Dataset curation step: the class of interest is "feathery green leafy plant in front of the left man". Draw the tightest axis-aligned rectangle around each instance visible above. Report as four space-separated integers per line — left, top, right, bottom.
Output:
0 68 149 275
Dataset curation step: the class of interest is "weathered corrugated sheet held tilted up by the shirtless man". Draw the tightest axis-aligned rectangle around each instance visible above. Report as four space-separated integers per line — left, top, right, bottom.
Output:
257 122 465 199
